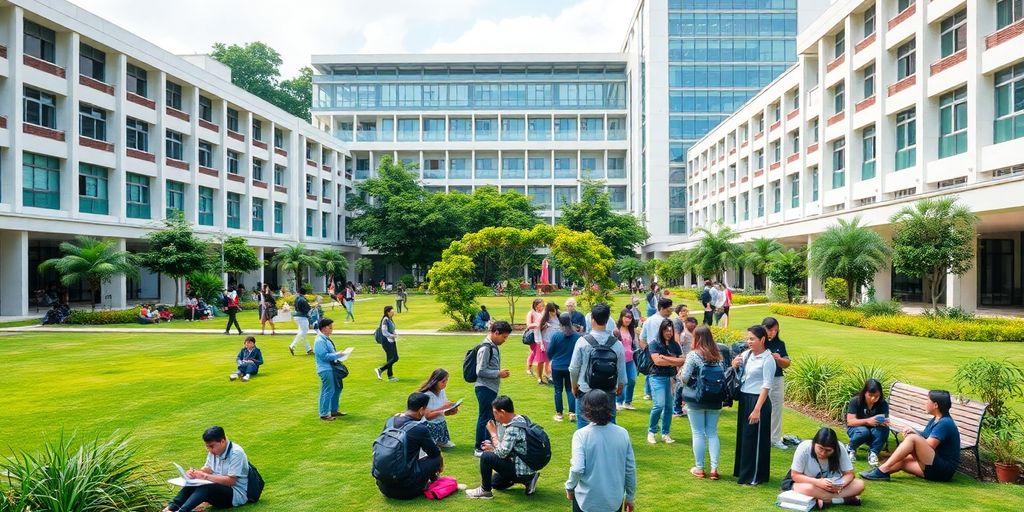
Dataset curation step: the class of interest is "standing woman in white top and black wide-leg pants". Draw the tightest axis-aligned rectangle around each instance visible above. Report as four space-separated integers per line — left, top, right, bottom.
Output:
732 326 775 485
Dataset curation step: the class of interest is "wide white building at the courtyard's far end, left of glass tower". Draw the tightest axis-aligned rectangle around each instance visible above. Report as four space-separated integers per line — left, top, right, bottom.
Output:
312 54 630 229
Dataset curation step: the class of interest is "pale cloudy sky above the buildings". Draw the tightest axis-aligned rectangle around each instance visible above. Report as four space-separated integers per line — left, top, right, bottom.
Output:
71 0 636 78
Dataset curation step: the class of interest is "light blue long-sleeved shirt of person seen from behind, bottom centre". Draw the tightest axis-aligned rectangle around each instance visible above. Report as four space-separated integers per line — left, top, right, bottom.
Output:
565 423 637 510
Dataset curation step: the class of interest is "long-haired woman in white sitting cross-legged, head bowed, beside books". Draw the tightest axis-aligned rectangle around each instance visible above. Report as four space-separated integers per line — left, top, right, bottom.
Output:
783 427 864 509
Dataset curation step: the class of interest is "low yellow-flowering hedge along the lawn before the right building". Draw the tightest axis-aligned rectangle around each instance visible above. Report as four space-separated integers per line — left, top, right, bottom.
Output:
769 304 1024 341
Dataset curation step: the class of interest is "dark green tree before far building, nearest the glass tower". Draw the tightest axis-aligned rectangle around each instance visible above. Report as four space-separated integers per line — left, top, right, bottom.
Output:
558 181 650 258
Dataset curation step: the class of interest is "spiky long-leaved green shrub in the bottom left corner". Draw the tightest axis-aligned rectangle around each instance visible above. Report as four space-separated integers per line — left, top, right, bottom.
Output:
0 435 164 512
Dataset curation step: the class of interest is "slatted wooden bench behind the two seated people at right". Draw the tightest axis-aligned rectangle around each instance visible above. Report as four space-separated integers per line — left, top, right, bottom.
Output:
888 382 988 476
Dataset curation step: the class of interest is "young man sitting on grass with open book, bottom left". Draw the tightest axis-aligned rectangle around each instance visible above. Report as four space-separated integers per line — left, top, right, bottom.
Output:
163 427 249 512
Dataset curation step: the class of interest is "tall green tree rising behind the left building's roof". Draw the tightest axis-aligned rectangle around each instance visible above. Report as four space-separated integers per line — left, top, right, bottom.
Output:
210 41 312 121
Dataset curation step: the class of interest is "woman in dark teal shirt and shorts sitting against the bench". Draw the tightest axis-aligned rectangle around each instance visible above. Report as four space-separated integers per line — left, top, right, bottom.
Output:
860 390 959 481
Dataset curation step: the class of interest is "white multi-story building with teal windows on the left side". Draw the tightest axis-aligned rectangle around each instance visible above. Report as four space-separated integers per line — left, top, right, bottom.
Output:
0 0 354 315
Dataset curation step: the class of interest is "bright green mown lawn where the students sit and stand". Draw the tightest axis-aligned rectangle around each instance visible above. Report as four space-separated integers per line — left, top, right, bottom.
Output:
0 296 1024 512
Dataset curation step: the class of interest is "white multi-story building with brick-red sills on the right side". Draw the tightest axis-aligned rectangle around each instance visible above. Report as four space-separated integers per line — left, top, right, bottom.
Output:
677 0 1024 309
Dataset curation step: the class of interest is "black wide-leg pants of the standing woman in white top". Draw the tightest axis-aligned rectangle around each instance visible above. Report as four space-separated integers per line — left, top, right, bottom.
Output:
732 393 771 484
